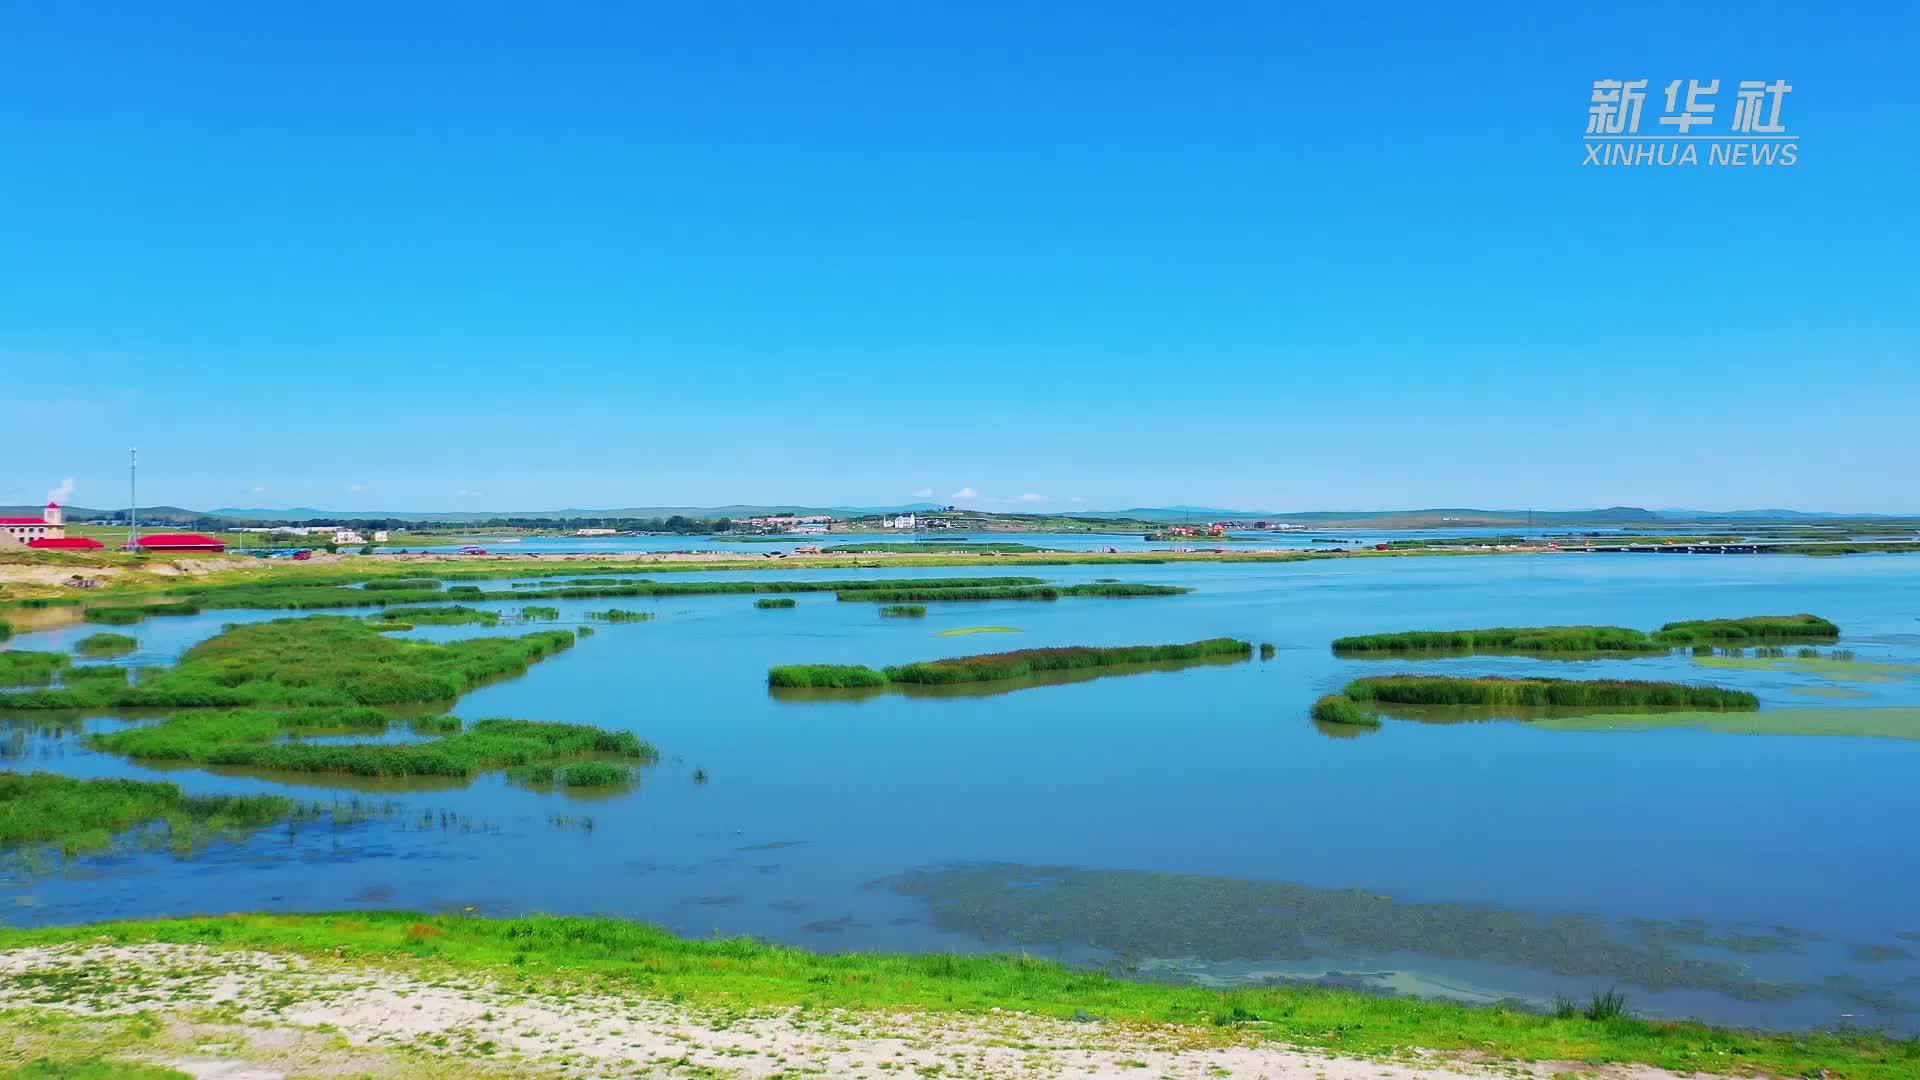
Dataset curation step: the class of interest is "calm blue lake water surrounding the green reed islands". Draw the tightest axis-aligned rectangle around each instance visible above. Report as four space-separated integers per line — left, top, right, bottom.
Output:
0 555 1920 1032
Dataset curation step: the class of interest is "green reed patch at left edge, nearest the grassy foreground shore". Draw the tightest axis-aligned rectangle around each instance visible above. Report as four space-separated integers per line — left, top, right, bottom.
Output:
0 773 294 853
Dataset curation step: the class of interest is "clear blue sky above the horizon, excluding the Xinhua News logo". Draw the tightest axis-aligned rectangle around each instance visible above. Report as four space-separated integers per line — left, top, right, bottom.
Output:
0 0 1920 511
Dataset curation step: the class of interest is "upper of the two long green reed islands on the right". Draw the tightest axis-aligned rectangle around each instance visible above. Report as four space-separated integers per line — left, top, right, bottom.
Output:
1332 615 1839 655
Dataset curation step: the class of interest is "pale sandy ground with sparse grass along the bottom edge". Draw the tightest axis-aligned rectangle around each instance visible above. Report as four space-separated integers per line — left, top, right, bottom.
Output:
0 945 1697 1080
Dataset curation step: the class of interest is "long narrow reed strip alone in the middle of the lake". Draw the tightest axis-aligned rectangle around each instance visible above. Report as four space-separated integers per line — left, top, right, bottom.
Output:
766 638 1254 688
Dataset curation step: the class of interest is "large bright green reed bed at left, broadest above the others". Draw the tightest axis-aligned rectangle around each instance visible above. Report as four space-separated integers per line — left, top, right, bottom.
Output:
0 615 574 709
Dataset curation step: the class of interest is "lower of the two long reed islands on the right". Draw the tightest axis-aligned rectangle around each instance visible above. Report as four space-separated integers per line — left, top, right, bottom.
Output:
1346 675 1761 711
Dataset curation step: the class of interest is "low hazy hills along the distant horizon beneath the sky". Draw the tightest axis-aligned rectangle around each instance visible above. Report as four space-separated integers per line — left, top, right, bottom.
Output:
11 502 1920 528
